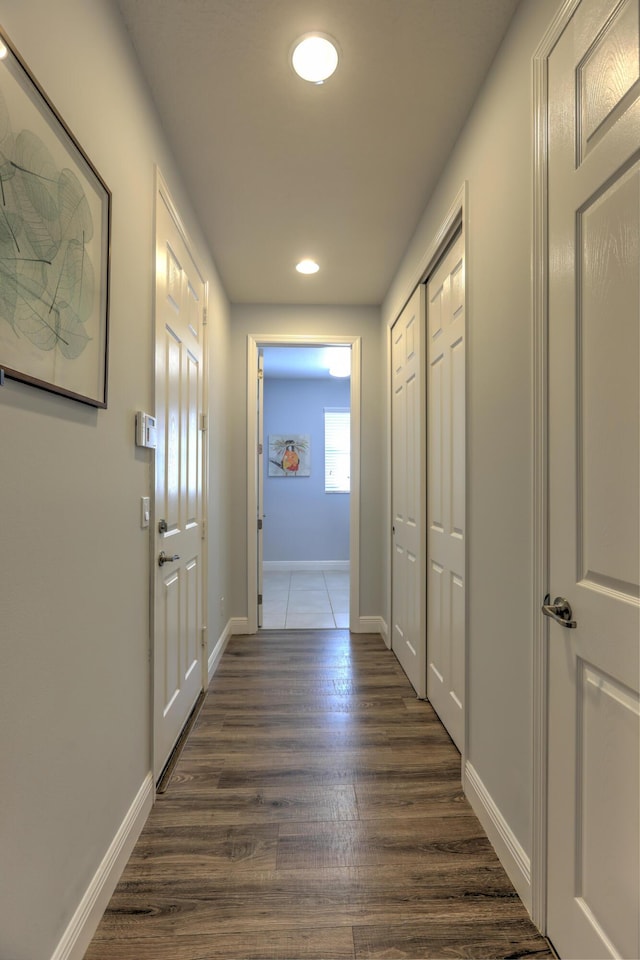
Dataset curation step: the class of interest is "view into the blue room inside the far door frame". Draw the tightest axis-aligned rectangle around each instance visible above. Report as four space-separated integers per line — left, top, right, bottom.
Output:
258 346 351 630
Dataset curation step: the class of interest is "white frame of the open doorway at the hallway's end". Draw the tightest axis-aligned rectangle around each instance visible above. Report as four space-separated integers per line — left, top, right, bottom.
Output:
247 334 360 633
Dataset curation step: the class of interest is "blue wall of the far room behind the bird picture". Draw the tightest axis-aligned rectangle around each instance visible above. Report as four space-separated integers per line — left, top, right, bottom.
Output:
263 378 350 561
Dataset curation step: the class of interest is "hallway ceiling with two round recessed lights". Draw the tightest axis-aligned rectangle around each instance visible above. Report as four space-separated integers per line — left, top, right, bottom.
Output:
115 0 518 305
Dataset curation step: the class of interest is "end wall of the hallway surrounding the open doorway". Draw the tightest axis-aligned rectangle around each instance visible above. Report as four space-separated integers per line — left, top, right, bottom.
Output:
228 305 385 617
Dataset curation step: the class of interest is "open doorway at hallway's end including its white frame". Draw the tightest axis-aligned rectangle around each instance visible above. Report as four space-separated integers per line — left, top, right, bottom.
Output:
247 336 360 633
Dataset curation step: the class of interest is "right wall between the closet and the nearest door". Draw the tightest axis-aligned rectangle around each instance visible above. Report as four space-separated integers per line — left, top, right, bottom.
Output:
383 0 560 876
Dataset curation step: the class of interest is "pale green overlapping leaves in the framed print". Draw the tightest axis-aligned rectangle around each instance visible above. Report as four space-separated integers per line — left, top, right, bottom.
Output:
0 85 95 360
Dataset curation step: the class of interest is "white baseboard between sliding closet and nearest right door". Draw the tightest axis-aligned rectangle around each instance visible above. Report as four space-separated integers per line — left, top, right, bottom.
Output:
463 760 531 913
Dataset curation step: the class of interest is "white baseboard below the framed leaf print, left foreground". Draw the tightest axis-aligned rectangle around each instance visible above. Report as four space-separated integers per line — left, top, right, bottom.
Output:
51 772 154 960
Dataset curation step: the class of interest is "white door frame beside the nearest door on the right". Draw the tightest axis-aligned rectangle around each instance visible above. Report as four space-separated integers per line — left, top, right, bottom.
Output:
530 0 580 933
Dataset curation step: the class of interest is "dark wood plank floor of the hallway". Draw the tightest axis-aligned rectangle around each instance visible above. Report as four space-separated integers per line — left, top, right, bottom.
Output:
85 630 553 960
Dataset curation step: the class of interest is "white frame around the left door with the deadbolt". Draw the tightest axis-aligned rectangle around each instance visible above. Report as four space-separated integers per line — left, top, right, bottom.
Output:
149 166 209 771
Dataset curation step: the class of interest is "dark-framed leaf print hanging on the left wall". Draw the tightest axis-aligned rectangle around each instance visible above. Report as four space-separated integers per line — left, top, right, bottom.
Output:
0 29 111 408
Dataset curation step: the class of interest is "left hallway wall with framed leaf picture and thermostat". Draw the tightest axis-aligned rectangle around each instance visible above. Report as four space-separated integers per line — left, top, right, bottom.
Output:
0 0 228 960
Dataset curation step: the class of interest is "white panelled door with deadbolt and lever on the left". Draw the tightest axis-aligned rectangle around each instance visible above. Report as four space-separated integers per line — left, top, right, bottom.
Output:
154 191 205 778
